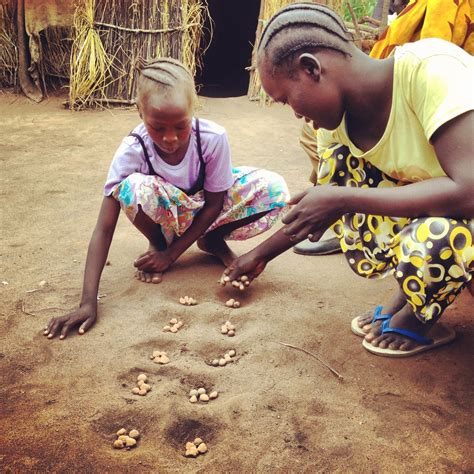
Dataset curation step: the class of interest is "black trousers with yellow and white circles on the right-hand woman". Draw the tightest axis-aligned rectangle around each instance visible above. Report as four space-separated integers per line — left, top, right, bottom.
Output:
318 145 474 322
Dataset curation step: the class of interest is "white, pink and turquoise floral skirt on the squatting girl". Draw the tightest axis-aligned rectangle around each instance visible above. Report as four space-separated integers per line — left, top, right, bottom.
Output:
112 166 290 244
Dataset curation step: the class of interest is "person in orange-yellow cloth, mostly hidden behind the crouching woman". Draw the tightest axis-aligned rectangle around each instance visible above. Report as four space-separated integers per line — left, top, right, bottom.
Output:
293 0 474 255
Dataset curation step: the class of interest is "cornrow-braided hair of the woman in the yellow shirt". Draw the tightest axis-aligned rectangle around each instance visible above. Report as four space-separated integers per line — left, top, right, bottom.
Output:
258 3 353 70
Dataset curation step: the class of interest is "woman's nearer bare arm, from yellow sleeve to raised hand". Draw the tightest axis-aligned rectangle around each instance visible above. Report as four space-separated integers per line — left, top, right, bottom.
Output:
283 112 474 240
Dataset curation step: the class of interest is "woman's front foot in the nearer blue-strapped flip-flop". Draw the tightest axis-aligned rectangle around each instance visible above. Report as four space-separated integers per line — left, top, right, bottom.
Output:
365 305 434 351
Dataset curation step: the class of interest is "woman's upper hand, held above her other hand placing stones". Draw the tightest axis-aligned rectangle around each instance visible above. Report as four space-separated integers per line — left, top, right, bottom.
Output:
282 185 343 242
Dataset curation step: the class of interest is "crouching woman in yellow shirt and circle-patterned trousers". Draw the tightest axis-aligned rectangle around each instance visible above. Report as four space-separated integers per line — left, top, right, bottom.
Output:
225 3 474 356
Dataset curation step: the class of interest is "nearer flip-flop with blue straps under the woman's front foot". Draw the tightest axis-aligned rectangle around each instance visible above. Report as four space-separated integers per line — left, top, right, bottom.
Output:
362 319 456 357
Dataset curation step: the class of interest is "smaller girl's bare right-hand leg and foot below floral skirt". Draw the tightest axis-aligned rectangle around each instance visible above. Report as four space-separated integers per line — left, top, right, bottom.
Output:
197 211 269 267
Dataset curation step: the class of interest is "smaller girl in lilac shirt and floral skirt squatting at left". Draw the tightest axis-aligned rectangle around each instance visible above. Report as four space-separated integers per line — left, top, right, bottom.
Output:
44 58 289 339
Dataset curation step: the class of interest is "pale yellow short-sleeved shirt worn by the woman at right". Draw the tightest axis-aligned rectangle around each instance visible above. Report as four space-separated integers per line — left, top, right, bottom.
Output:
317 38 474 183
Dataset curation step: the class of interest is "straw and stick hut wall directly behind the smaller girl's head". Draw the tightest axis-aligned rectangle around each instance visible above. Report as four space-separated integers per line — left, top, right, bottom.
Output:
70 0 208 108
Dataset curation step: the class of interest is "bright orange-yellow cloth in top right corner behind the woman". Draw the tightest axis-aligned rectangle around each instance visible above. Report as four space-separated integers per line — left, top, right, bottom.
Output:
370 0 474 58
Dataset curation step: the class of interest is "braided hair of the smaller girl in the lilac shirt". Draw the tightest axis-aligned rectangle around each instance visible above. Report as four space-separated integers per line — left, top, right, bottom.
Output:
137 58 197 105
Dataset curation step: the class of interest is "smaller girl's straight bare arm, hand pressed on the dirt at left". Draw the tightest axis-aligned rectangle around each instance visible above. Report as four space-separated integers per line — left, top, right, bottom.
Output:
44 197 120 339
